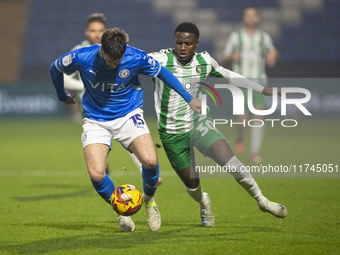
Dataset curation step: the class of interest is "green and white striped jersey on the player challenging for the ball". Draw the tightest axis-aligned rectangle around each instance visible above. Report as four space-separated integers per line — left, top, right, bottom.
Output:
150 49 229 134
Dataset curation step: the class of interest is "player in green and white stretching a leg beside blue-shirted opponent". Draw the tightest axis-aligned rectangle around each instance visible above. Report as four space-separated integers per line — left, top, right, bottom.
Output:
150 22 288 226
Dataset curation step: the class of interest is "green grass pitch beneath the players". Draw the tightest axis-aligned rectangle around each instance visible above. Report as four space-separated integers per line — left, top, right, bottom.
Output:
0 120 340 254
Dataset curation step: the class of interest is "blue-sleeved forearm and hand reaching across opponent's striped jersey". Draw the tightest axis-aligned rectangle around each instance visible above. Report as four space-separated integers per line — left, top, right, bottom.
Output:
157 66 201 113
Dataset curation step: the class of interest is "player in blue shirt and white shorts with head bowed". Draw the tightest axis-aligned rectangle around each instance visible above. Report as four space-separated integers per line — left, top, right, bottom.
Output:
50 28 201 232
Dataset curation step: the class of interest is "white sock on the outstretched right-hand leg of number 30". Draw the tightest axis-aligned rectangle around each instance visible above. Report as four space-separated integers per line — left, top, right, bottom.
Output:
226 156 264 201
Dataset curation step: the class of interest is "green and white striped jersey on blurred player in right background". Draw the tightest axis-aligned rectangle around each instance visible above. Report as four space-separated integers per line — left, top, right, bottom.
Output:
224 29 274 85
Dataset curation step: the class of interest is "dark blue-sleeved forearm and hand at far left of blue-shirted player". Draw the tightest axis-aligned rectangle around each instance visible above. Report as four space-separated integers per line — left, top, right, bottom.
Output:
50 62 76 105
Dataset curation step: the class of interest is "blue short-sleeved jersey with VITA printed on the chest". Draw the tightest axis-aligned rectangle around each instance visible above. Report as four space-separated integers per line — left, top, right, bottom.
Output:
54 44 161 121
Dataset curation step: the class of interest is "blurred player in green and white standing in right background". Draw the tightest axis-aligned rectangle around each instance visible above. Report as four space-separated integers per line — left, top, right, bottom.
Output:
223 7 278 163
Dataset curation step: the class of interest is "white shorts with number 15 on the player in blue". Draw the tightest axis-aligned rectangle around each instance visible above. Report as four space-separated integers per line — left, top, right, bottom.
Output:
81 108 150 149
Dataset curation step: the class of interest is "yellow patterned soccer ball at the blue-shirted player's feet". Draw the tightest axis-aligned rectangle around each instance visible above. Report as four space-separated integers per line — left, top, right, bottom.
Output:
111 184 143 216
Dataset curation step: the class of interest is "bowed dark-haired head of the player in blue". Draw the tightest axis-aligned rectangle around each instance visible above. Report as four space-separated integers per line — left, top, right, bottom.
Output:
101 27 128 59
